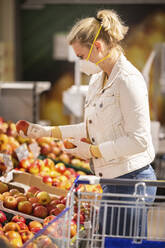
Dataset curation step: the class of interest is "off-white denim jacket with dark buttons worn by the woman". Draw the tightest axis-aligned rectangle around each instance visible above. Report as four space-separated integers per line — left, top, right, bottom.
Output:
60 55 155 178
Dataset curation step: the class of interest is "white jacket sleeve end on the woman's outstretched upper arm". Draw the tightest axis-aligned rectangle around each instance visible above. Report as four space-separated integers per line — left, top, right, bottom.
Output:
59 122 87 139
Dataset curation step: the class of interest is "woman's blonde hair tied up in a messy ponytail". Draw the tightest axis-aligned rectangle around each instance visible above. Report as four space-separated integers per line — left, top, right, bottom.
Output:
67 10 128 47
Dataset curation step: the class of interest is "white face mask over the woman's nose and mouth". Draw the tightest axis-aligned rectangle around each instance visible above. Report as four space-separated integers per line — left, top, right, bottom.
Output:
80 60 102 76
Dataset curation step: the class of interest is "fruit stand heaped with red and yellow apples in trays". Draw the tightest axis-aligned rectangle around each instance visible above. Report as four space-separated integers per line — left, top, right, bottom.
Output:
0 118 102 248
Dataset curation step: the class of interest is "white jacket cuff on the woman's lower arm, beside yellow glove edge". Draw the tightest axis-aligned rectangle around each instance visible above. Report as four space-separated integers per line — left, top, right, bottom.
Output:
99 141 118 162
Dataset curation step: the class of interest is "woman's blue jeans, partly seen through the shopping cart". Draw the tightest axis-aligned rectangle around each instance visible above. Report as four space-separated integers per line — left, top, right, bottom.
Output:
99 165 157 237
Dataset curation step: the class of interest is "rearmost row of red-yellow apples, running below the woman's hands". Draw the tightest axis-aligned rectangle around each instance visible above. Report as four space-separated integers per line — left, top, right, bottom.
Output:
0 117 89 175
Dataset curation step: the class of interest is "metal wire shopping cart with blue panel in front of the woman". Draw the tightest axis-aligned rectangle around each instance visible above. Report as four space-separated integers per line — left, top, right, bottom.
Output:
67 176 165 248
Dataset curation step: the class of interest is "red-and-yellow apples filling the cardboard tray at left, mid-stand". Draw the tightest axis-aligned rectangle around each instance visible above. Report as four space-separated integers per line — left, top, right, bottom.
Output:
0 184 66 219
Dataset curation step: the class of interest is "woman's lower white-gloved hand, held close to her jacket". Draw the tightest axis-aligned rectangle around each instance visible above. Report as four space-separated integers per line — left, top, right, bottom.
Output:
63 139 92 160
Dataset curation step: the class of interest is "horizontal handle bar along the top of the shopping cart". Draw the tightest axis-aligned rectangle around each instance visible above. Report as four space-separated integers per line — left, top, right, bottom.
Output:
76 176 165 188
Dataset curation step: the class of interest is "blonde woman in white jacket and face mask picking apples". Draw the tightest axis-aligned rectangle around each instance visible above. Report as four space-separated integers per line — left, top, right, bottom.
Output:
16 10 156 238
